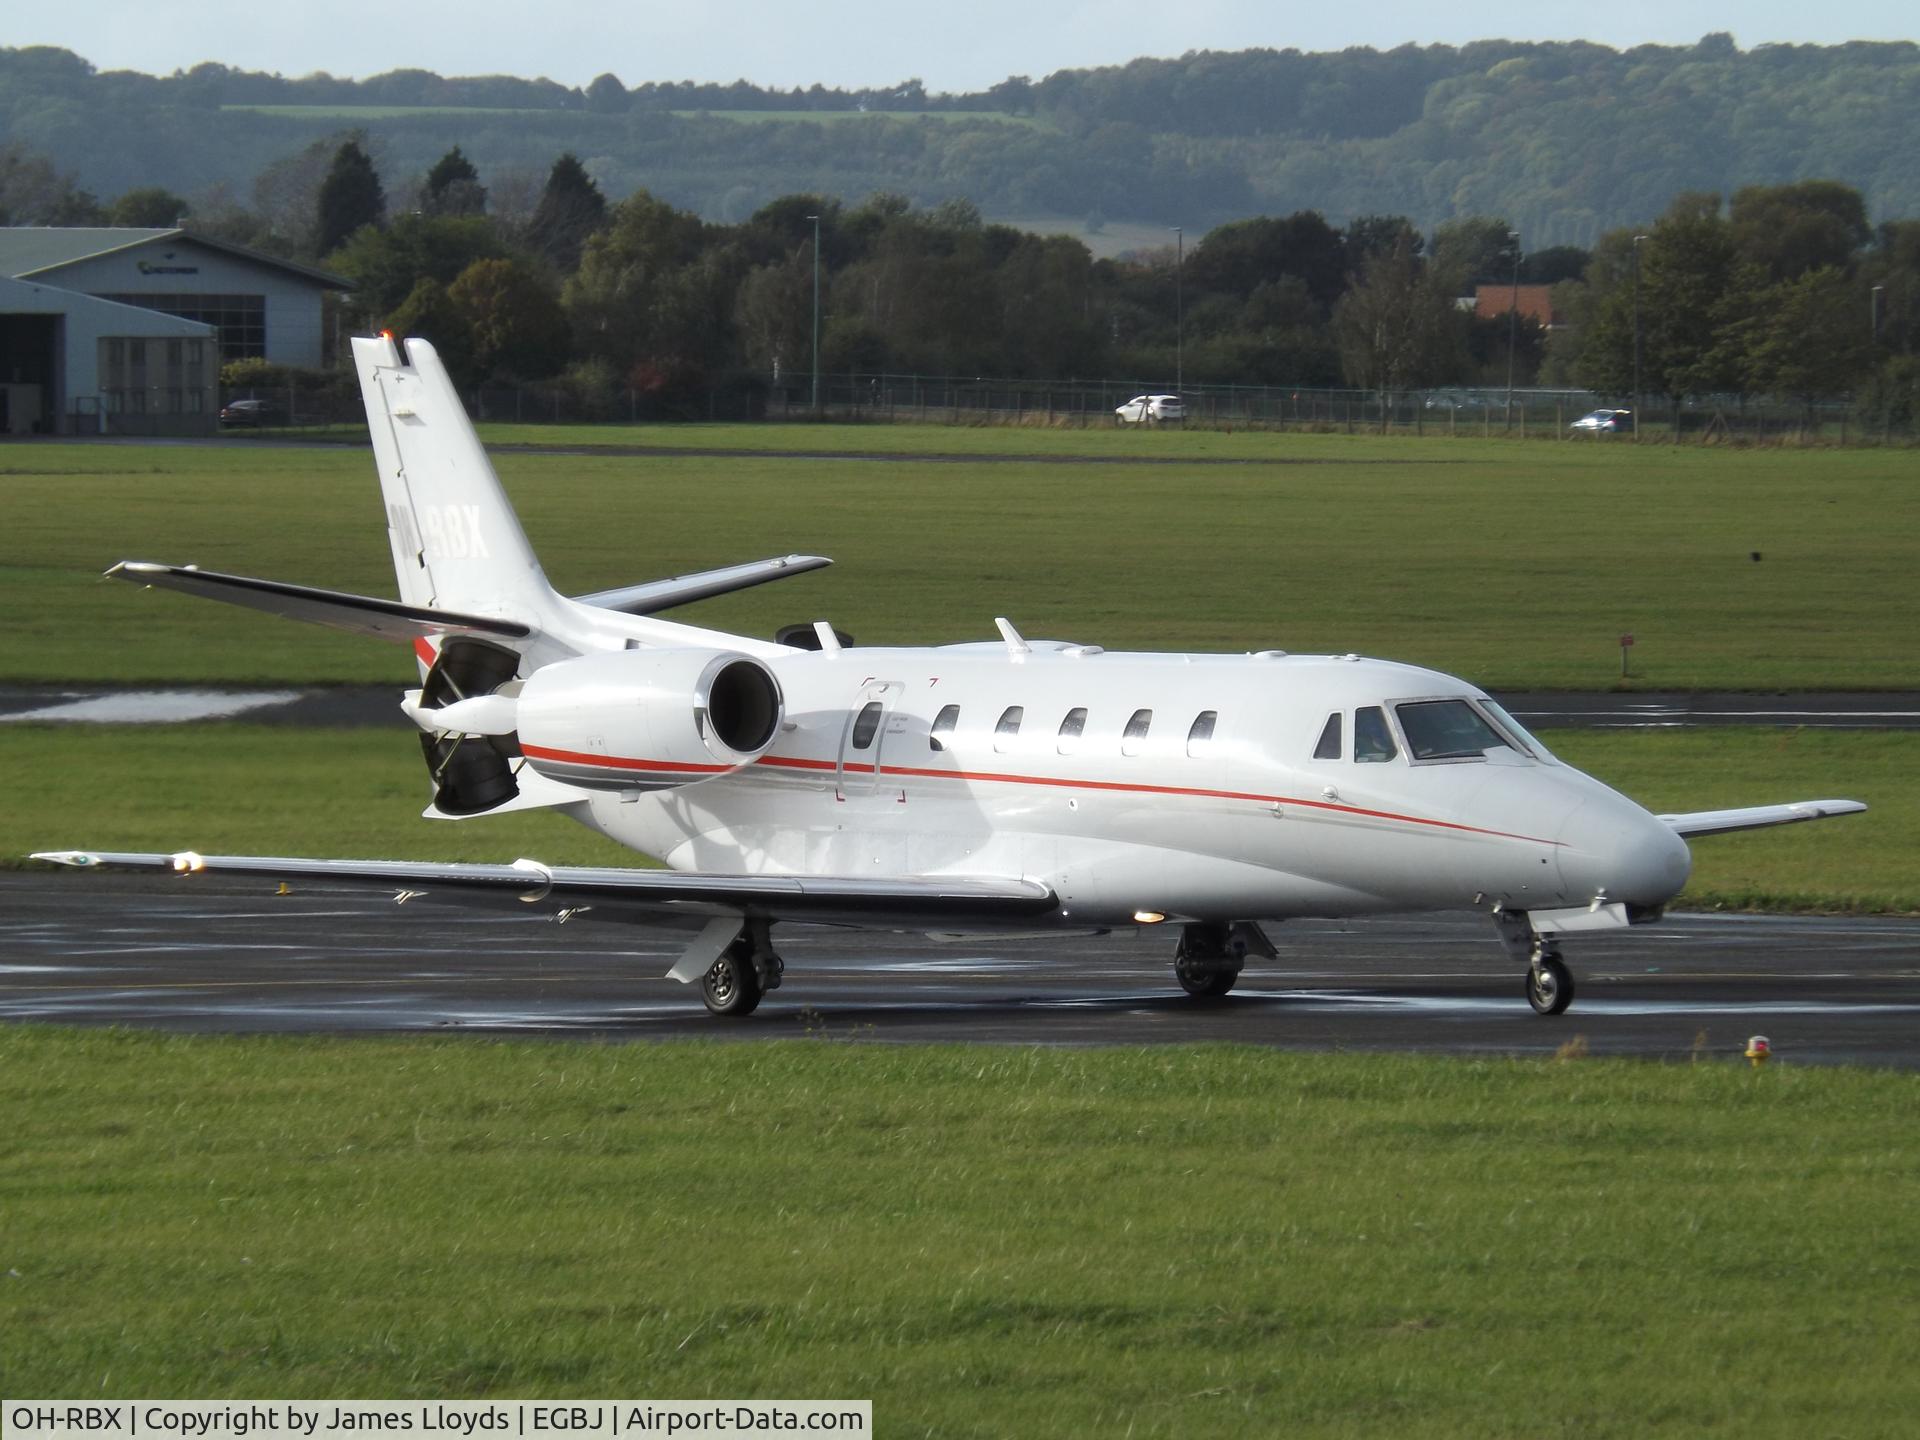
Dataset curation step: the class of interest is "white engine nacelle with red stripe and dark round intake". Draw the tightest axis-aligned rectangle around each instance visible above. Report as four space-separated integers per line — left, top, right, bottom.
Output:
515 649 783 789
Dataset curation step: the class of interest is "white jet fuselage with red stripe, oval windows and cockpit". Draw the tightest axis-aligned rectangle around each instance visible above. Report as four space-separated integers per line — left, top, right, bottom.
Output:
560 643 1690 925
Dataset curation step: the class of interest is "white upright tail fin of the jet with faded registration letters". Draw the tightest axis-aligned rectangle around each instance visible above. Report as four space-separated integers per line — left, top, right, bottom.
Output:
353 334 563 626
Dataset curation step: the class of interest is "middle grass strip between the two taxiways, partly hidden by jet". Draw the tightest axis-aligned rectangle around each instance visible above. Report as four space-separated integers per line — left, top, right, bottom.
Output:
11 724 1920 912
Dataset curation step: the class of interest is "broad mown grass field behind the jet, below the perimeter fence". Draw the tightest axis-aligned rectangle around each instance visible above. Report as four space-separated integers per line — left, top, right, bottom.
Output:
0 426 1920 689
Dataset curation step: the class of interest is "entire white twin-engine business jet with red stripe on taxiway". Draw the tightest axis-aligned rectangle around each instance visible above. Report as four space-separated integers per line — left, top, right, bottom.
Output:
40 334 1866 1016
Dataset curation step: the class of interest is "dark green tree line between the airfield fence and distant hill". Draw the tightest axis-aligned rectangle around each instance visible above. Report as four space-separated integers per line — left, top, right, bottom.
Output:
0 127 1920 422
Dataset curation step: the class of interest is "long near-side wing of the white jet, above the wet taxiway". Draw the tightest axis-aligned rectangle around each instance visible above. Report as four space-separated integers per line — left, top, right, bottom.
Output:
33 851 1058 929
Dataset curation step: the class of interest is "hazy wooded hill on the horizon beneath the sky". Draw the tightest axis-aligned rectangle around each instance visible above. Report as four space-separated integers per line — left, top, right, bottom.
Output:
0 35 1920 240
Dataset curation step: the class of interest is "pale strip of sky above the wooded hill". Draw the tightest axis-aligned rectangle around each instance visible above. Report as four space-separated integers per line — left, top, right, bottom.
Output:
18 0 1920 92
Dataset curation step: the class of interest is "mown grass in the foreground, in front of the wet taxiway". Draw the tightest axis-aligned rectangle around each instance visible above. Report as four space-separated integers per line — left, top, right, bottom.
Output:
0 1027 1920 1440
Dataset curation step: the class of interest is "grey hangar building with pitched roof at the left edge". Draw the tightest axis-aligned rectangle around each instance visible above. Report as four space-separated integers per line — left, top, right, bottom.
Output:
0 227 351 434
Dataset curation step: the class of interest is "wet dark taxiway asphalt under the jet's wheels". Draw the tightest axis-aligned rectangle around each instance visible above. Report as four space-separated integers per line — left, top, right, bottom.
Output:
0 872 1920 1068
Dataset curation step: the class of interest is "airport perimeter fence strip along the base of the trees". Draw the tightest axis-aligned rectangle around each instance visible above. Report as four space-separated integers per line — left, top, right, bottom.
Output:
221 372 1920 445
